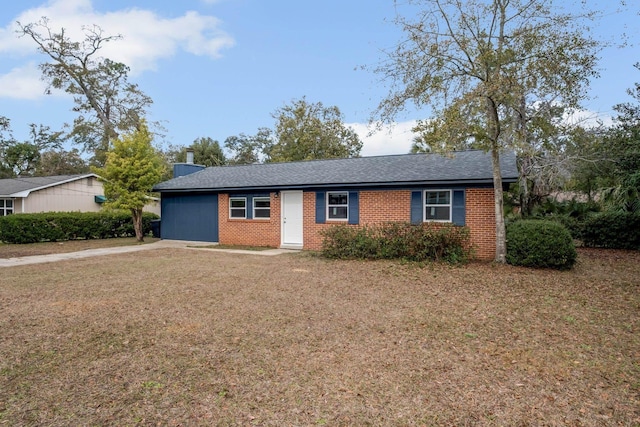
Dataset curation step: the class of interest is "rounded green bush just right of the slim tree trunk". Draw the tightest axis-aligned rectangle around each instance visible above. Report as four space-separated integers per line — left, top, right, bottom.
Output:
507 220 578 270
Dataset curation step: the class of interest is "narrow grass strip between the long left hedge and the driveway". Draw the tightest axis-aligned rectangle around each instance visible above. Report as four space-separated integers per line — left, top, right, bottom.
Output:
0 237 160 259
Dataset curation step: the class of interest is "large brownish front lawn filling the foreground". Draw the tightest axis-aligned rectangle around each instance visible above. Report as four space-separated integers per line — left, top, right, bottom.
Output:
0 249 640 426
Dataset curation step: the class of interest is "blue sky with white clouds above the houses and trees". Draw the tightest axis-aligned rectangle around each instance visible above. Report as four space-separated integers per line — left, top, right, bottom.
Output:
0 0 640 155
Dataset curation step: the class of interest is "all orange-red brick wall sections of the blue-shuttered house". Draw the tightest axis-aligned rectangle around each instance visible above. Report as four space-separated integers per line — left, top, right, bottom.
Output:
218 188 496 260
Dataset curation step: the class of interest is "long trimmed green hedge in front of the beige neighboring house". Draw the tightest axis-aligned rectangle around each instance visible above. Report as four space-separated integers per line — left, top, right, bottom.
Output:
0 211 159 243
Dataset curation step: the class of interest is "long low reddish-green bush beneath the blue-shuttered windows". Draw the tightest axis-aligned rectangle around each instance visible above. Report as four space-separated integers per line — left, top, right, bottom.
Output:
320 222 471 263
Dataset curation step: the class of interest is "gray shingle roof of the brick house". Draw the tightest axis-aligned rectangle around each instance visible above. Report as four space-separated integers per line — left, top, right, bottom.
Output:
154 150 518 192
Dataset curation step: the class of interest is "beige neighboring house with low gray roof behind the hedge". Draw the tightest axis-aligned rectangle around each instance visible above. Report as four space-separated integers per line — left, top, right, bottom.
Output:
0 173 160 216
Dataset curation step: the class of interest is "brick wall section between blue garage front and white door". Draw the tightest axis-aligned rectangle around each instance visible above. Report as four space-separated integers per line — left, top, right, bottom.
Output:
218 193 280 248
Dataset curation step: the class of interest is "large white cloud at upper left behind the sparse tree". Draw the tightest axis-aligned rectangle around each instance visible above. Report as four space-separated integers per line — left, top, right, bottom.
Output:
0 0 234 96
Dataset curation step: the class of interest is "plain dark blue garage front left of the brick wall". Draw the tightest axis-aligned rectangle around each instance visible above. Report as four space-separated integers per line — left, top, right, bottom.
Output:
160 193 218 242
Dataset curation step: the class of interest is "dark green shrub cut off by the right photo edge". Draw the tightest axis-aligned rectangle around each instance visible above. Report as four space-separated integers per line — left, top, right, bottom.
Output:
581 212 640 250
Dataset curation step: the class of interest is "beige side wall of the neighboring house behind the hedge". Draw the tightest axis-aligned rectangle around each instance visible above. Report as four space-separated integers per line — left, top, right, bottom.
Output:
24 177 104 213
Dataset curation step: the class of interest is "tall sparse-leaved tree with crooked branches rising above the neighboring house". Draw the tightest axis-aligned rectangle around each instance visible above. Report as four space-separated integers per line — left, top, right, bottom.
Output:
18 18 152 166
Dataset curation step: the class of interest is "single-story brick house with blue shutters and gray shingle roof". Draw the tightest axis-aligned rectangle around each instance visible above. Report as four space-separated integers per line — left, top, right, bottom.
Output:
154 150 518 259
